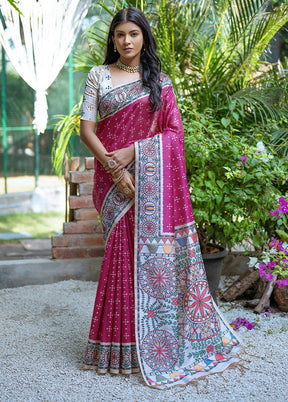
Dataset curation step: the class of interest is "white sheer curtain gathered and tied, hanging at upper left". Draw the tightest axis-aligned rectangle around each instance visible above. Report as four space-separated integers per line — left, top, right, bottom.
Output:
0 0 91 134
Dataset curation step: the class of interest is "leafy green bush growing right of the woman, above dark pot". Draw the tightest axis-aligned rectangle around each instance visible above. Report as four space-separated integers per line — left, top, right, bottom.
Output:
180 105 288 253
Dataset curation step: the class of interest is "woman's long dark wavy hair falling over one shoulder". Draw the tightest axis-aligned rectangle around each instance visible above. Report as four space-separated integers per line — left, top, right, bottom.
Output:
104 7 161 112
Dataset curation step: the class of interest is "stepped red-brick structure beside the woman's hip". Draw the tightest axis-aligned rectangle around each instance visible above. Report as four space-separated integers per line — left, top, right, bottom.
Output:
51 158 104 259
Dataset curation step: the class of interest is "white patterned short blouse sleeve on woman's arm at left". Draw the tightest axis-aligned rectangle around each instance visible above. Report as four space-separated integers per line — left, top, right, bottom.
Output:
81 67 99 123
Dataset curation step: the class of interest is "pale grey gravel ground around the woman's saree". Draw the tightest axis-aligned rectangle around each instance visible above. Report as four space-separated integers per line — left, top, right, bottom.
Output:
0 280 288 402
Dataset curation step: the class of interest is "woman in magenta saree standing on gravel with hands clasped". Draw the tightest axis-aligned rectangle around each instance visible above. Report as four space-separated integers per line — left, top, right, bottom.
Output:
81 8 240 388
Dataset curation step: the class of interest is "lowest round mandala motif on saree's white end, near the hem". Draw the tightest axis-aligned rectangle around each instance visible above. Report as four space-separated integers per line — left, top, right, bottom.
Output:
141 329 179 371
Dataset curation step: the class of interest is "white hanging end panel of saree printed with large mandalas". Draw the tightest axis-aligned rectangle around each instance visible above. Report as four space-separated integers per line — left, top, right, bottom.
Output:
134 134 241 389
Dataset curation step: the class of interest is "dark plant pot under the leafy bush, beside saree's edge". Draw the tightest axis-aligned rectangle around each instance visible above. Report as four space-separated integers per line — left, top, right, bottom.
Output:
202 245 228 304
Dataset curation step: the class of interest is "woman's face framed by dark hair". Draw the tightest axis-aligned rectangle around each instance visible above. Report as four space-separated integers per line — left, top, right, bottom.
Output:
112 22 144 64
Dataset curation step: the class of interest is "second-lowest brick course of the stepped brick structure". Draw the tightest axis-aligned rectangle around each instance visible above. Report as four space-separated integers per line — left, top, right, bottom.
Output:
51 233 104 248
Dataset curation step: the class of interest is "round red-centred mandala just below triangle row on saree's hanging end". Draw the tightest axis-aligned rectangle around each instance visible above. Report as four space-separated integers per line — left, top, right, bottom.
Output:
139 257 176 299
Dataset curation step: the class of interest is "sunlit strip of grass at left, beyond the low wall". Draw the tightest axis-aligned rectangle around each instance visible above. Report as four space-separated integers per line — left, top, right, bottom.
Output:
0 211 65 242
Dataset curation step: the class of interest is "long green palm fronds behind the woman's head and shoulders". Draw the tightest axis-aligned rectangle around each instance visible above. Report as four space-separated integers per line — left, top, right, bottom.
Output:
52 0 288 174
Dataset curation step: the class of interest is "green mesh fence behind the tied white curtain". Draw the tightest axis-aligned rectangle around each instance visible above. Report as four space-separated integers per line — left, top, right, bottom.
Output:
0 48 89 193
